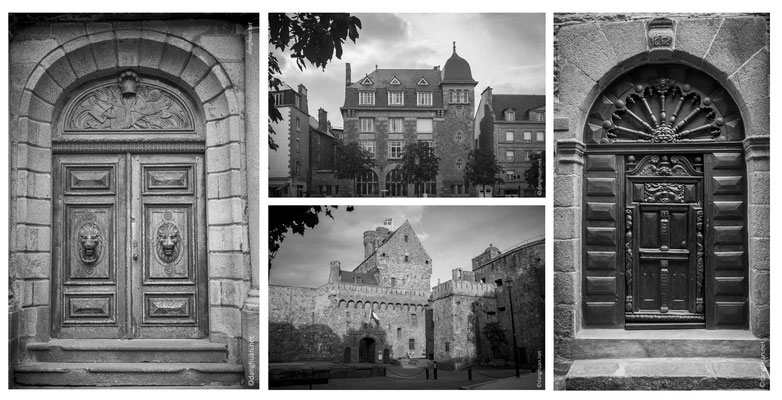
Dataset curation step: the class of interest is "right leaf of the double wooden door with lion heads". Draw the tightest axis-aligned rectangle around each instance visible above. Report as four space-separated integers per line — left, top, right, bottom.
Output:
131 155 207 338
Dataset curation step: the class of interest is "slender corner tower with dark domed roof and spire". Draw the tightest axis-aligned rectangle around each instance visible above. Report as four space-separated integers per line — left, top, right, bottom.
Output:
434 42 478 195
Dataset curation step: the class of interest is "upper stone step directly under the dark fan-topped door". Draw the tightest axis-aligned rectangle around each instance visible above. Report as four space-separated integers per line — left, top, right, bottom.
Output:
571 329 770 360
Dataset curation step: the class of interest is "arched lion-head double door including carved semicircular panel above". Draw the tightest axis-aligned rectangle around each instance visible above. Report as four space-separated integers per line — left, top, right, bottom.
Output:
52 69 209 338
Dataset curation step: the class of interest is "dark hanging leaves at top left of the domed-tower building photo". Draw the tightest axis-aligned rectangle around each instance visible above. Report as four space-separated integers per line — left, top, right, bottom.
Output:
267 13 361 150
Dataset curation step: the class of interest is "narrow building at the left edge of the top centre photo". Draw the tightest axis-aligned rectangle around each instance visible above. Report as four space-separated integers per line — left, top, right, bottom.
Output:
269 83 311 197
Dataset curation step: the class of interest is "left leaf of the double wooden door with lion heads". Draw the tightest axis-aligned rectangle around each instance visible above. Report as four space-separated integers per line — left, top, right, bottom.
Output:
52 155 127 338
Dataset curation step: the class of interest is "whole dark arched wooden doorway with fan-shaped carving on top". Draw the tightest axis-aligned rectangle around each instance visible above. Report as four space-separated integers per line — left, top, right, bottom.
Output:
582 64 749 329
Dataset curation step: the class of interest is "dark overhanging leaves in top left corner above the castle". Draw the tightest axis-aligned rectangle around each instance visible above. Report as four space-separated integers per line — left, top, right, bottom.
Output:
269 206 353 270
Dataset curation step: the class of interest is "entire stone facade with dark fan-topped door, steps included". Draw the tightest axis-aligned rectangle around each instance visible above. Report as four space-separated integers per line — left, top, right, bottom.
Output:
554 14 770 389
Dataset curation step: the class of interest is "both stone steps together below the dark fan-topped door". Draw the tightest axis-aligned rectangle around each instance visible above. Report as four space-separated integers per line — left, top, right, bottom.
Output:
560 329 770 390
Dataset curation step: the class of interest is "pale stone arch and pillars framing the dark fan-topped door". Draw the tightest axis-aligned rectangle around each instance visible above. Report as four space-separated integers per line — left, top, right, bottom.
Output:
554 14 770 373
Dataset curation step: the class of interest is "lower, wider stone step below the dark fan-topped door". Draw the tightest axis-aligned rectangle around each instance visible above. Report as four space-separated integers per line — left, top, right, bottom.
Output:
564 358 769 390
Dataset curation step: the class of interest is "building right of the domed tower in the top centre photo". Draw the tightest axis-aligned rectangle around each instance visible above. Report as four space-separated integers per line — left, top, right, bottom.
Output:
475 87 546 197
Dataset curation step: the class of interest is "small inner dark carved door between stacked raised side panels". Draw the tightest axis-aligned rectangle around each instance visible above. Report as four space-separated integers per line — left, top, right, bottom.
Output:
624 155 704 328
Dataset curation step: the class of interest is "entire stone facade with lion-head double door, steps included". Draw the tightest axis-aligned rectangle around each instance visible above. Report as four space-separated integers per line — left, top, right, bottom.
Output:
8 14 260 387
